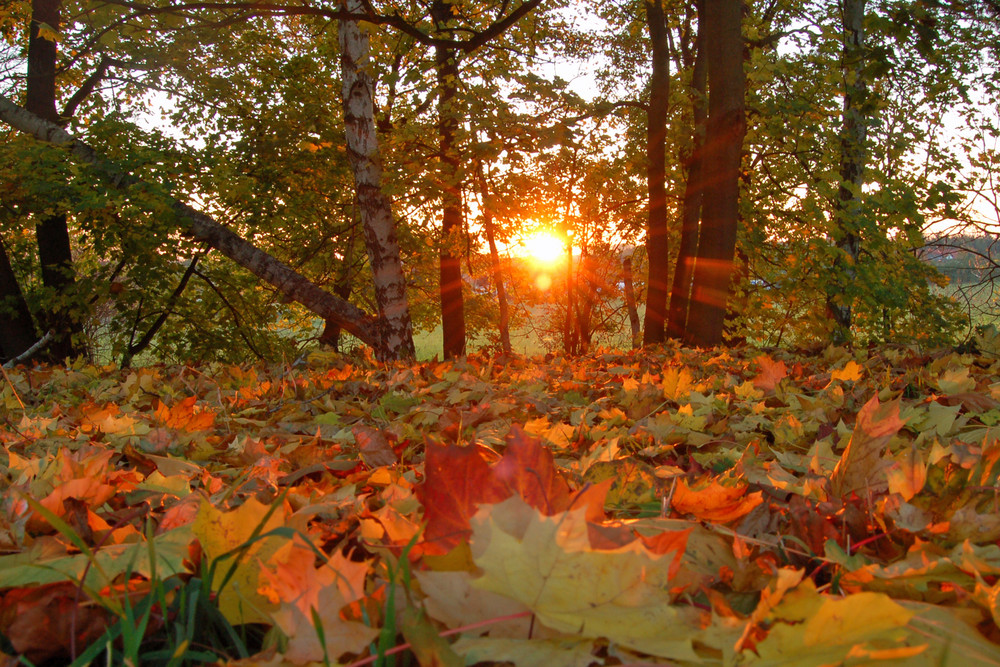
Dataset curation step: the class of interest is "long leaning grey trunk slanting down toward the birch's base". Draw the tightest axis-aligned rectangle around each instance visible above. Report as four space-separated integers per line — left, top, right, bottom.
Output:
0 95 380 349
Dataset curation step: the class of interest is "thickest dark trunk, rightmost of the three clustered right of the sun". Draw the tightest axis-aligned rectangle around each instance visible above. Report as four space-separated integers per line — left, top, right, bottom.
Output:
686 0 746 347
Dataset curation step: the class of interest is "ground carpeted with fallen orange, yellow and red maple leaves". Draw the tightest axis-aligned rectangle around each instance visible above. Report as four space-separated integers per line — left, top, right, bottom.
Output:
0 348 1000 667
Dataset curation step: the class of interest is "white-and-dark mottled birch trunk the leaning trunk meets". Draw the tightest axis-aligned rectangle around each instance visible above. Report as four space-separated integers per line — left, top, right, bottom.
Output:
340 0 416 360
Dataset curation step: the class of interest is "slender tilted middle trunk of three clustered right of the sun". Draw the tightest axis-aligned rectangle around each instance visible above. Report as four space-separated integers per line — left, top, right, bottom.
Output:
667 0 708 340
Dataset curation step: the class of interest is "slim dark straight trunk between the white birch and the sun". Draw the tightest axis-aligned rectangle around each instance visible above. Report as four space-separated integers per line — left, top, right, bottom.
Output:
435 36 465 358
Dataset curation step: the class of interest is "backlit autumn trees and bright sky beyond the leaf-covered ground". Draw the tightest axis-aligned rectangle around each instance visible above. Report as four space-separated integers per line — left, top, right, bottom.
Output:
0 0 997 363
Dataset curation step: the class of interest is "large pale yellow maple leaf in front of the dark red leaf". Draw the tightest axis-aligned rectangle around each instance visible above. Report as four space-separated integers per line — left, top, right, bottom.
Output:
471 496 708 660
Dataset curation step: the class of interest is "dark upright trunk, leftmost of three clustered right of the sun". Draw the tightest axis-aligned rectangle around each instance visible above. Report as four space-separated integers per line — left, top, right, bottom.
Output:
642 0 670 345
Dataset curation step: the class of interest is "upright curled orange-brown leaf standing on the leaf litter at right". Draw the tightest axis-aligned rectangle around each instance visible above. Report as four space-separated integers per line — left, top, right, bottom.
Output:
830 396 906 497
